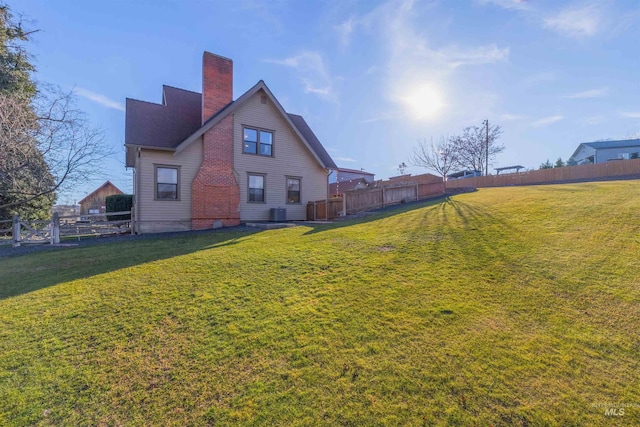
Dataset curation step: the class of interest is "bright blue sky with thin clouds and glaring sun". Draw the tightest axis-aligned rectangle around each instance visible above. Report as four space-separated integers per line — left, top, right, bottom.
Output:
8 0 640 203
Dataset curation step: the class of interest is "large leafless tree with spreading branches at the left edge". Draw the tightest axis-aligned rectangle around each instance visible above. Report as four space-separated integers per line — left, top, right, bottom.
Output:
0 88 113 209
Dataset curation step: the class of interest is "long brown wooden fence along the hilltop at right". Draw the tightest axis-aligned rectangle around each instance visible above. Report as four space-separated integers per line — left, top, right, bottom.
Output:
447 159 640 188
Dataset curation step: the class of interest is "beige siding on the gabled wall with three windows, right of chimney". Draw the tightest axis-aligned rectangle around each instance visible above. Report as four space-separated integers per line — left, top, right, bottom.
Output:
233 91 327 221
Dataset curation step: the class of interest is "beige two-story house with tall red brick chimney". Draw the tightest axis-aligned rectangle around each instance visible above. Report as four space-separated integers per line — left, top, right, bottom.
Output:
125 52 337 232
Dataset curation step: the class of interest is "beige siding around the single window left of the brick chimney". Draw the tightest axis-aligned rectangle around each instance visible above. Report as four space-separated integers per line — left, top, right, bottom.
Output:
136 140 202 233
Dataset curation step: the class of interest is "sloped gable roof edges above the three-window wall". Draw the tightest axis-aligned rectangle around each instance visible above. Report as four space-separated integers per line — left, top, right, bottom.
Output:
175 80 337 169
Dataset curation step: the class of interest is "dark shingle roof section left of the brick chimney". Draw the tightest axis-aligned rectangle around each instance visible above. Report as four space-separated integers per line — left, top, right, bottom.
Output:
125 86 202 148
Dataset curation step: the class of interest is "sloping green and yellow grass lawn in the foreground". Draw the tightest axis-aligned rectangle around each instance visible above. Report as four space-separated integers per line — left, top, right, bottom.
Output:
0 181 640 426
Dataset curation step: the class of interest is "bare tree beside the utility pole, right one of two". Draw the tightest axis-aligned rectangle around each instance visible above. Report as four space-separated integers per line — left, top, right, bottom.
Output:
452 125 504 175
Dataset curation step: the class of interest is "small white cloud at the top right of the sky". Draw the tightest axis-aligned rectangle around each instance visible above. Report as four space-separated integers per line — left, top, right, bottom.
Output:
543 2 603 38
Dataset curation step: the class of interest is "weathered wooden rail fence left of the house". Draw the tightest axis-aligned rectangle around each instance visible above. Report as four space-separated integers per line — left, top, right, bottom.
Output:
7 211 134 247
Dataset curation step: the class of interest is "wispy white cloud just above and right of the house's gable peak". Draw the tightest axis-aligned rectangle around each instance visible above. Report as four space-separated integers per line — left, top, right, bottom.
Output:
265 50 338 102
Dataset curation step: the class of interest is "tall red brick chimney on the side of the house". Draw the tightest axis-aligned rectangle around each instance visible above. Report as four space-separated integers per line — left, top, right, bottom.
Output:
191 52 240 230
